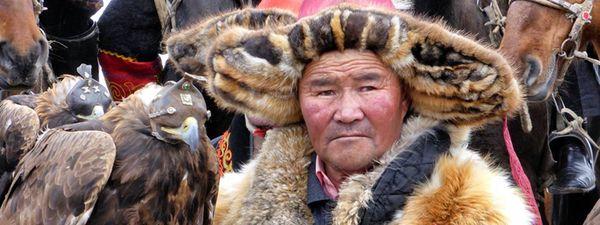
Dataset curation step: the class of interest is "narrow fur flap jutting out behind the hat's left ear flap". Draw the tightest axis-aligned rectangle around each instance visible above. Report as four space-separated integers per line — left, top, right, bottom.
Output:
167 8 296 75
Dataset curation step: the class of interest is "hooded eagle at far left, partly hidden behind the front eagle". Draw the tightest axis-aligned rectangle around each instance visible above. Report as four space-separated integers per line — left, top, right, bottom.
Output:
0 75 112 201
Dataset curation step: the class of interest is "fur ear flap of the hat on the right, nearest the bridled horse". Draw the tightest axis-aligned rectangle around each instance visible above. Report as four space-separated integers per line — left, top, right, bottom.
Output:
404 18 522 125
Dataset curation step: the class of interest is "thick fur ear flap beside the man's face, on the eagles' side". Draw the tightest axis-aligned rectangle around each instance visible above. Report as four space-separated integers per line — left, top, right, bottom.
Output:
207 28 304 125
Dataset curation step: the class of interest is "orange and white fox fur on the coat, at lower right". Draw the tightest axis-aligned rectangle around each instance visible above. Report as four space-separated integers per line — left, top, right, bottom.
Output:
390 149 533 225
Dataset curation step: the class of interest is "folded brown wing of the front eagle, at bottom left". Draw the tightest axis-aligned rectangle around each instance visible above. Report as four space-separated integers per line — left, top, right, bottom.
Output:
0 130 115 225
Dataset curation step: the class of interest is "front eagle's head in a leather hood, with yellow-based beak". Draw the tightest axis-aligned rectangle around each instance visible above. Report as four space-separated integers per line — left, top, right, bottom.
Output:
149 77 209 151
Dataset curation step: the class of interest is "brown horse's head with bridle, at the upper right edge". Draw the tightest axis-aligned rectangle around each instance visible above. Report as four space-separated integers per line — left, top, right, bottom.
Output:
500 0 600 101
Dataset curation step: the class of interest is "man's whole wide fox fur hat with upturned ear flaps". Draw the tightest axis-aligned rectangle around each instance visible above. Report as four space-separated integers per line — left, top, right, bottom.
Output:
167 4 522 126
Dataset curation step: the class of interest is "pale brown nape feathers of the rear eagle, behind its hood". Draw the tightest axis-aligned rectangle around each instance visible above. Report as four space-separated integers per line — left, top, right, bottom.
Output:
35 75 83 128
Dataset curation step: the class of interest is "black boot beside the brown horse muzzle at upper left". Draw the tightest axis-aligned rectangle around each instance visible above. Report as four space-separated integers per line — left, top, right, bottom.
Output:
39 0 103 80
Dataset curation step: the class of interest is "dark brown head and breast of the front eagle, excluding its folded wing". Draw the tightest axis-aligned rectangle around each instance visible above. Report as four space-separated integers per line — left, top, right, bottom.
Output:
90 78 218 224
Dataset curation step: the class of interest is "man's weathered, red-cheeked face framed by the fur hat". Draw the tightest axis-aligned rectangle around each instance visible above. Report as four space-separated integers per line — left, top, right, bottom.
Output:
299 50 409 175
